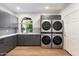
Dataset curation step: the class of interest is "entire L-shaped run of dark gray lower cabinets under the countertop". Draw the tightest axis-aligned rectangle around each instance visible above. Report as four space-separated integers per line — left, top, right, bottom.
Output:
0 35 41 55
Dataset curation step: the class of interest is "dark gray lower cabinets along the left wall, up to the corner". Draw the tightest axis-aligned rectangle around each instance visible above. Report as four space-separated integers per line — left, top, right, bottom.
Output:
0 36 16 55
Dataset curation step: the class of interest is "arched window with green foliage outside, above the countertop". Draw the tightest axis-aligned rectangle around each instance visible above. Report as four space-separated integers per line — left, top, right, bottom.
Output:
21 17 33 33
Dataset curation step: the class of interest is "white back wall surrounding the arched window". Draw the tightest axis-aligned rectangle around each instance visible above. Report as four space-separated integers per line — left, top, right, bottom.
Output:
16 13 57 33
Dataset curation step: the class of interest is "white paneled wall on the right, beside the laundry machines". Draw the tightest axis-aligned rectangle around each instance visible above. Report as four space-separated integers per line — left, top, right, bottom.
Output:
60 3 79 55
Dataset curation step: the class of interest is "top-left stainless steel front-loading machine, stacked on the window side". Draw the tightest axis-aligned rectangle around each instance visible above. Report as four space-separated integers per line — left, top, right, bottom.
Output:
41 19 51 32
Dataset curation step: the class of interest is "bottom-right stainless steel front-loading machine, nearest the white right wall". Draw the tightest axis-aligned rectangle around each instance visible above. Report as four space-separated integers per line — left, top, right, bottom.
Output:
52 34 63 48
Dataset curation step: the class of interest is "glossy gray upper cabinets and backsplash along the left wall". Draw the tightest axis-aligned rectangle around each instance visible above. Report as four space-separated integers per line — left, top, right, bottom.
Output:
0 11 18 35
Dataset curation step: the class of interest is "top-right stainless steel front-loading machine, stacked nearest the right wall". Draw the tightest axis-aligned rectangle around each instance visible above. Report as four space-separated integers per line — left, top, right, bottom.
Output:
52 20 63 32
